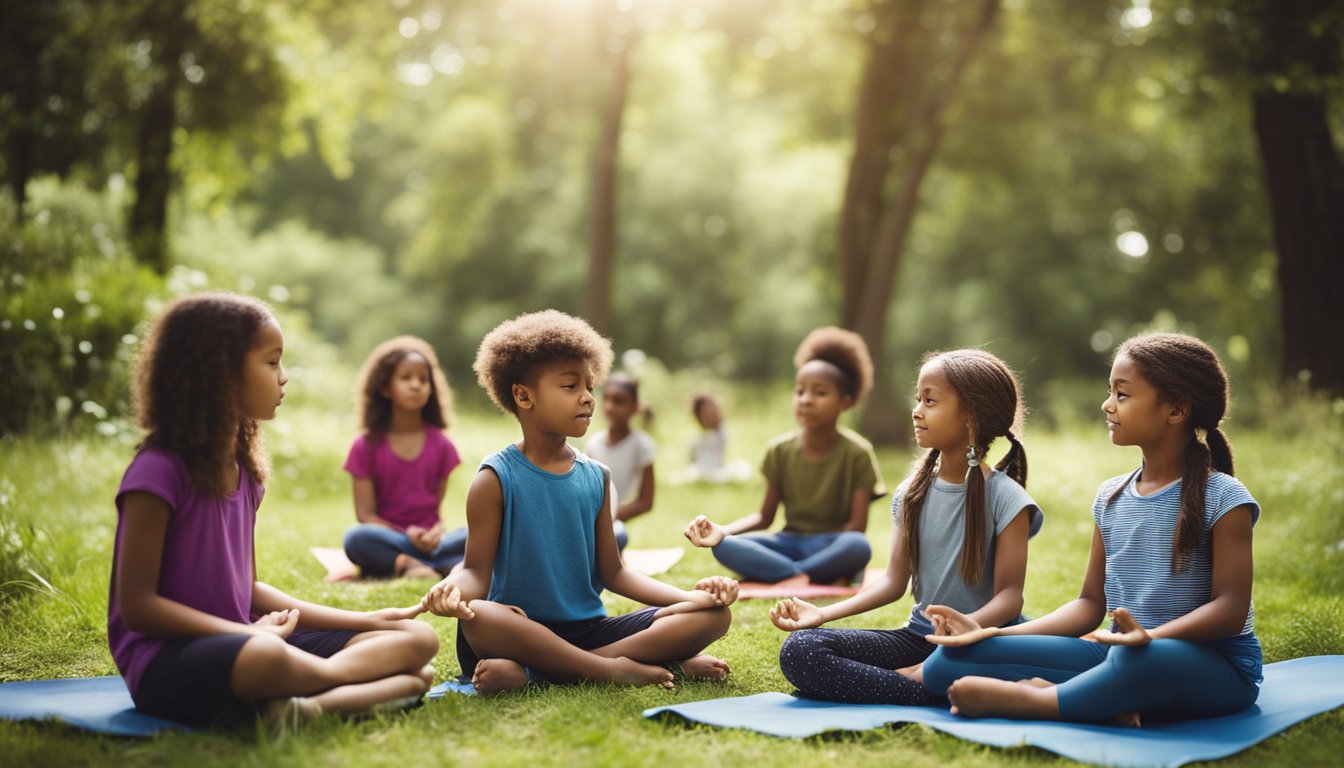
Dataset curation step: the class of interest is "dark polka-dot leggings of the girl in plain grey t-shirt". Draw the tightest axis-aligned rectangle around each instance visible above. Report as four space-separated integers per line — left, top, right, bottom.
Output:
780 627 946 705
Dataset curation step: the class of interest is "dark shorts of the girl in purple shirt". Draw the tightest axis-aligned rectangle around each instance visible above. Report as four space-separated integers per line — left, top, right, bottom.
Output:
132 629 356 726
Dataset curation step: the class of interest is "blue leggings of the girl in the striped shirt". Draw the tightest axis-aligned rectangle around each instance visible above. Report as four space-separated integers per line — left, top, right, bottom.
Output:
923 635 1259 722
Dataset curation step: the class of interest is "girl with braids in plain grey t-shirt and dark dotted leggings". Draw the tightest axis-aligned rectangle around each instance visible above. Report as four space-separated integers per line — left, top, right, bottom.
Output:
770 350 1043 705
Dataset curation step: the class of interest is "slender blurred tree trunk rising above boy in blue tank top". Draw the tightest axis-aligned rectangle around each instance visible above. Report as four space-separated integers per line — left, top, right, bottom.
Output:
583 30 634 335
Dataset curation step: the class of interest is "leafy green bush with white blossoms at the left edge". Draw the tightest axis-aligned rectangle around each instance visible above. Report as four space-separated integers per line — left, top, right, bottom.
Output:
0 183 163 434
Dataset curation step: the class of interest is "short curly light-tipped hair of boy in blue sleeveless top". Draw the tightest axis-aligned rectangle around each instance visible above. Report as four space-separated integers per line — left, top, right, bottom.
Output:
472 309 613 416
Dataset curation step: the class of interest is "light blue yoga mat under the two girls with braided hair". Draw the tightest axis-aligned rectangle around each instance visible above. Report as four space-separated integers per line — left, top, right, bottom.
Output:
644 656 1344 768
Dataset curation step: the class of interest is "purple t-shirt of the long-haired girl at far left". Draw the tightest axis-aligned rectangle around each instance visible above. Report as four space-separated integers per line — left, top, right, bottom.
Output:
108 448 265 694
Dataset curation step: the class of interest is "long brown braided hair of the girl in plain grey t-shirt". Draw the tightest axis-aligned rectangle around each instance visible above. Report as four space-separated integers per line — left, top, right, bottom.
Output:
900 350 1027 584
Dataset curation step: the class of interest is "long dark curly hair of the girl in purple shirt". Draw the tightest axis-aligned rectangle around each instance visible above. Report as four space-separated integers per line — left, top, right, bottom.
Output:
133 292 276 498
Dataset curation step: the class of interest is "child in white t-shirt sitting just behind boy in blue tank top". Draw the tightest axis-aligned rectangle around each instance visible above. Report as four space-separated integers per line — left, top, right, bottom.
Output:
583 374 657 550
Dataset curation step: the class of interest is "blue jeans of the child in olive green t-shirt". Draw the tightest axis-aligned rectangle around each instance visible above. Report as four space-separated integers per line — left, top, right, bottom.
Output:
714 531 872 584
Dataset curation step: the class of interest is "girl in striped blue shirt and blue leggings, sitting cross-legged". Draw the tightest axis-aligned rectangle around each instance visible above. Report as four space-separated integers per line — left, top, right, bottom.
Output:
923 334 1261 725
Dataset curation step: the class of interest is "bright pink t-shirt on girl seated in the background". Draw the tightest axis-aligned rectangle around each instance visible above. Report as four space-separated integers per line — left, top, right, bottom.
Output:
344 428 462 531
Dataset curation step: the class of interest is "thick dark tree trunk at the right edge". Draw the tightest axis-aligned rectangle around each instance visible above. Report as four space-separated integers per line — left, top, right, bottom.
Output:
1253 90 1344 395
